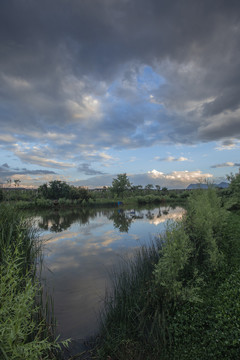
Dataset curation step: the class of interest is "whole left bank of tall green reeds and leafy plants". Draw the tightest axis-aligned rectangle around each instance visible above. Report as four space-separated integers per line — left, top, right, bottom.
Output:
0 204 68 360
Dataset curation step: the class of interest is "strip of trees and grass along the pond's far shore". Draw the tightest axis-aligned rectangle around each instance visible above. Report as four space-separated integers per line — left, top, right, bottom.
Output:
0 174 226 209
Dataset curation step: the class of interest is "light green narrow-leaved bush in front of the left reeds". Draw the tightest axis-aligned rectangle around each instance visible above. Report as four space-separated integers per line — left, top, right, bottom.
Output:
0 253 60 360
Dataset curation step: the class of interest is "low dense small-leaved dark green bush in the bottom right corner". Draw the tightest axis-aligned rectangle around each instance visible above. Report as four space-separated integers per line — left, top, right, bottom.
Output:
169 269 240 360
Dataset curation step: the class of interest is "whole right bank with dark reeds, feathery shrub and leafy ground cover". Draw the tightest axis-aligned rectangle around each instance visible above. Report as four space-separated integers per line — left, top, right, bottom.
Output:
94 189 240 360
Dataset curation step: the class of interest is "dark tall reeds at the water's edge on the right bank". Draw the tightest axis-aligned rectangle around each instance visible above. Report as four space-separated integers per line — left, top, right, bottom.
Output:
96 238 169 360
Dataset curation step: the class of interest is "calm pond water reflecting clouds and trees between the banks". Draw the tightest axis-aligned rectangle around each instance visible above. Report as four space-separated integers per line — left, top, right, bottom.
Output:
32 207 184 339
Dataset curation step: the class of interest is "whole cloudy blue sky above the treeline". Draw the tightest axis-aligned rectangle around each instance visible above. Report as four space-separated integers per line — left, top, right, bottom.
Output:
0 0 240 188
